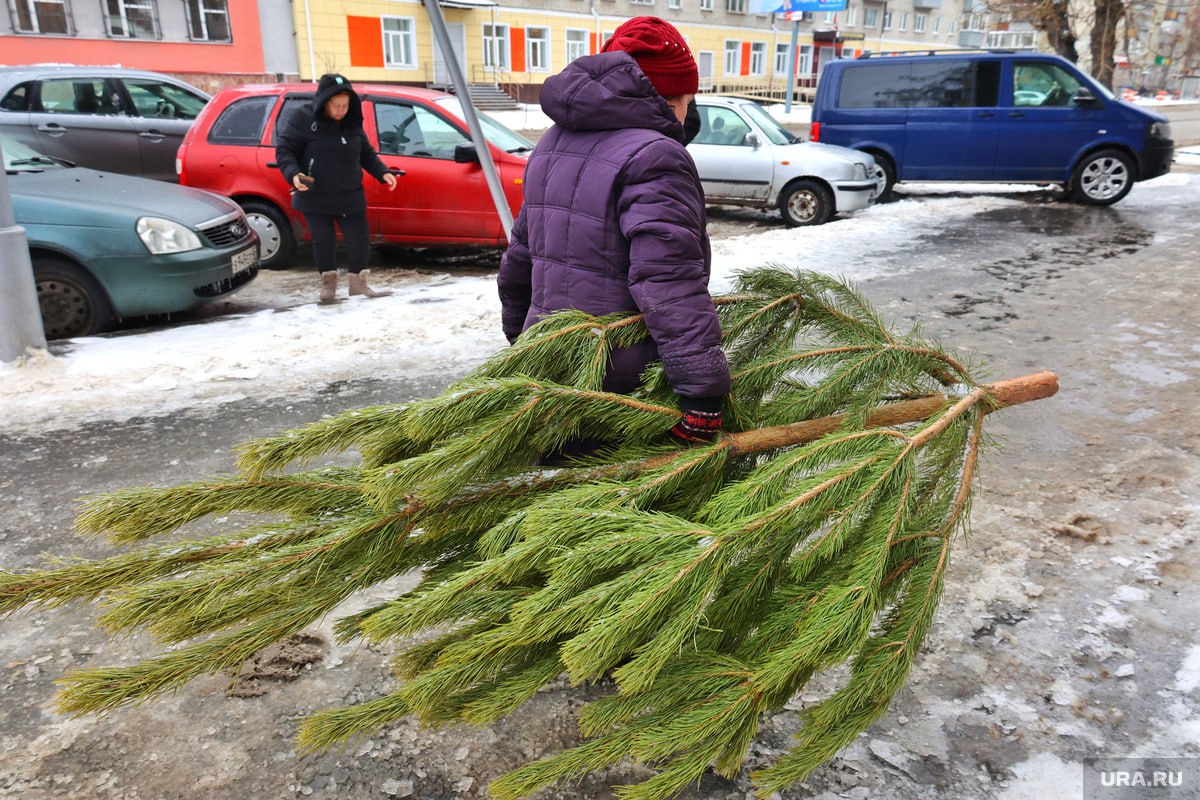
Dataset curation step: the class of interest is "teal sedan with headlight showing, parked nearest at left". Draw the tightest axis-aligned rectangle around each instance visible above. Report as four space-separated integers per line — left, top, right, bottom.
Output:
0 134 258 339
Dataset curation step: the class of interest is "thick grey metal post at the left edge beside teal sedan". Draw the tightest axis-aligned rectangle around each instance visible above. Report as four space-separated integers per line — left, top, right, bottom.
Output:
0 140 46 361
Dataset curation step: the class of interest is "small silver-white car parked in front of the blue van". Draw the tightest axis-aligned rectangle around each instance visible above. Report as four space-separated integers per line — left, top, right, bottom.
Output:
688 95 884 225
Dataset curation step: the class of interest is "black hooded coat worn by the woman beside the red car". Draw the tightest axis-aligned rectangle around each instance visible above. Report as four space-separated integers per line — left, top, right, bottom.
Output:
275 74 388 216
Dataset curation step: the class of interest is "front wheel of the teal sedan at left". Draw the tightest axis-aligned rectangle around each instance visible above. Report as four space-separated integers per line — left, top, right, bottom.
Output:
32 255 115 339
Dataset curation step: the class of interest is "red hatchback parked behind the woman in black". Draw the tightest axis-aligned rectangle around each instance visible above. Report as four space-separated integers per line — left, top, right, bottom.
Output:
175 84 533 269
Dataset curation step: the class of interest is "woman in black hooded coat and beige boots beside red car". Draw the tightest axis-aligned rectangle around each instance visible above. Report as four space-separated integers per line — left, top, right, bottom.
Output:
275 73 396 302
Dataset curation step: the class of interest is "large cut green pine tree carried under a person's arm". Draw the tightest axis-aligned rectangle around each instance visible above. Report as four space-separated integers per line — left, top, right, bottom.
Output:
0 269 1056 799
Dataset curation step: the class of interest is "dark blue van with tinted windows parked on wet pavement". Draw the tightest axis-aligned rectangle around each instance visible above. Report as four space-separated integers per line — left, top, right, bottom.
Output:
810 50 1175 205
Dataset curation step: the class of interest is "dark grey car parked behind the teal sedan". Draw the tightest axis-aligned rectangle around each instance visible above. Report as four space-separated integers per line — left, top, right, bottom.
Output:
0 65 209 182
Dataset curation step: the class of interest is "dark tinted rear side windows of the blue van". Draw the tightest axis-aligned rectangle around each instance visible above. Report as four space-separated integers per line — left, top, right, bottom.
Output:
838 59 1000 108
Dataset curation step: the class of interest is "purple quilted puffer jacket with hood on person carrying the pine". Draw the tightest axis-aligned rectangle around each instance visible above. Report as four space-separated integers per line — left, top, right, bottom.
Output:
499 52 730 398
